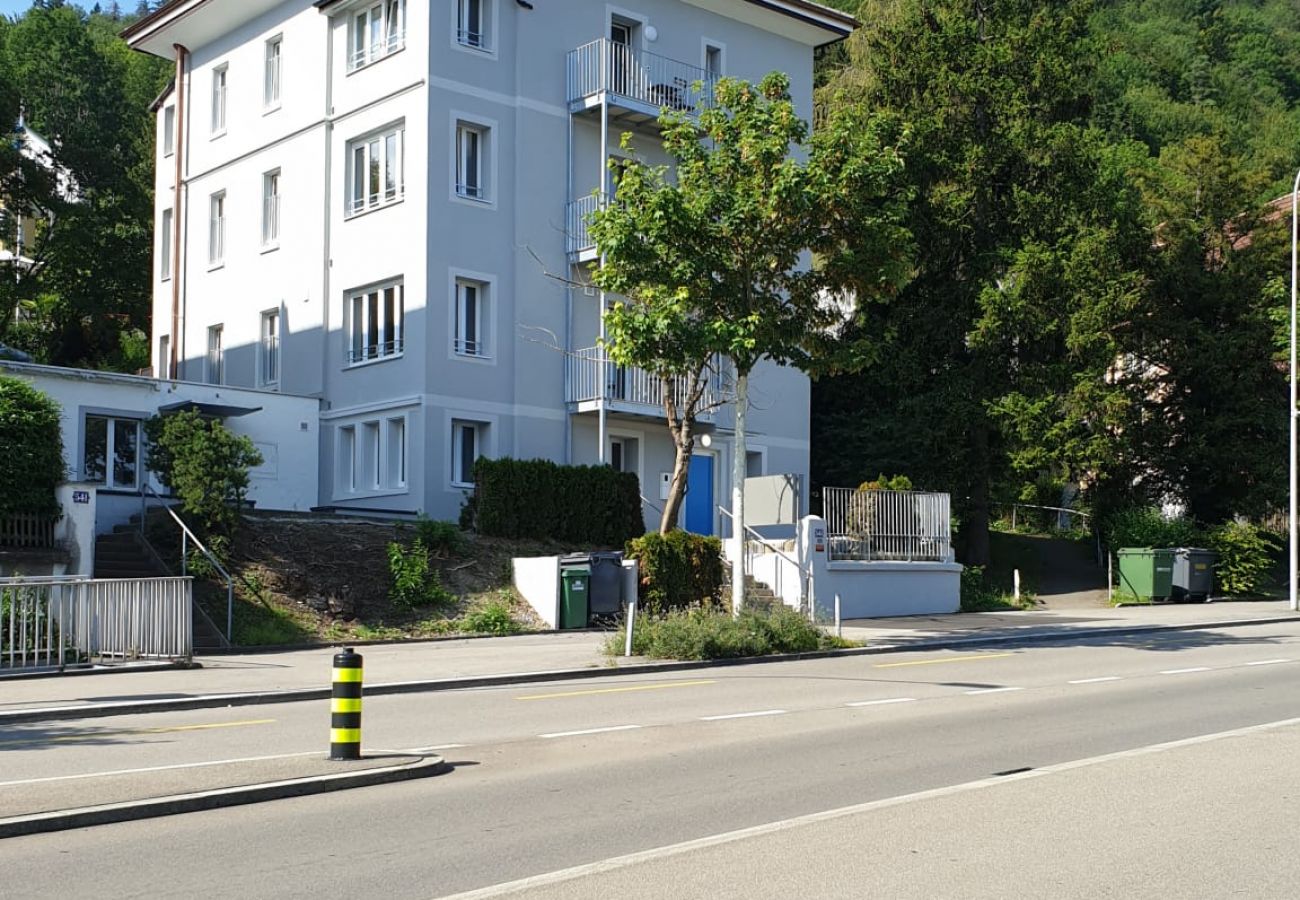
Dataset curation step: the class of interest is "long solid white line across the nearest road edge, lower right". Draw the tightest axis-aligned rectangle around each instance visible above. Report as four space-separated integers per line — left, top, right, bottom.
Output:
443 718 1300 900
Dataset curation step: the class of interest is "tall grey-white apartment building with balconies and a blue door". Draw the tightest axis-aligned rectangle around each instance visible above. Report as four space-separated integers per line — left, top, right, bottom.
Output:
125 0 855 533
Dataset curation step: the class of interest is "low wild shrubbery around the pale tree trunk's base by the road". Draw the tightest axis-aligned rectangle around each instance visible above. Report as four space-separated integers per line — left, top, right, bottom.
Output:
606 606 845 659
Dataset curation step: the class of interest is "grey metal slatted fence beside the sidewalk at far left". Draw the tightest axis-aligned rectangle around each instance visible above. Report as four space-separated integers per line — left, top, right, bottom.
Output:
0 576 194 674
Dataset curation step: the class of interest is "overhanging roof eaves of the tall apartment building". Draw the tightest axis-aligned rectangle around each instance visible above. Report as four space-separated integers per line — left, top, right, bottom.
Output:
122 0 858 57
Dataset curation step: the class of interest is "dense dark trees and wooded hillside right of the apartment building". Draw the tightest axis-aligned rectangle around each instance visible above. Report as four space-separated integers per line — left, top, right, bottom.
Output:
813 0 1300 562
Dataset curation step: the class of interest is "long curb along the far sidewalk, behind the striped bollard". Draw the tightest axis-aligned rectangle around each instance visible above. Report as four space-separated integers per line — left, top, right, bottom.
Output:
0 615 1300 727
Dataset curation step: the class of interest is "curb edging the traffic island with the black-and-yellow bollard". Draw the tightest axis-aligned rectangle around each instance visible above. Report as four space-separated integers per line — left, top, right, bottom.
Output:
0 756 451 839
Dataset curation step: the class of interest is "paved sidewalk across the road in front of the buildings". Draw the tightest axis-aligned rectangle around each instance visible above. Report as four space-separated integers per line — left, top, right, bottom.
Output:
0 601 1300 726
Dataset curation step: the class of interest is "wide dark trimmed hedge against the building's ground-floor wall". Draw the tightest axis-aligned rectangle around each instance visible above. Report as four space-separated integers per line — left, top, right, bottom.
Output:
469 458 645 546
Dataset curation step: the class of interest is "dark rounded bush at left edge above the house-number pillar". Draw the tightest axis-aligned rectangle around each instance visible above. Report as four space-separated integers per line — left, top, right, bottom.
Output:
0 376 64 516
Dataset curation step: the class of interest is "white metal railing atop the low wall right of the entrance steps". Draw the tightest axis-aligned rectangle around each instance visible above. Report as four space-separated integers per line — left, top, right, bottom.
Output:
822 488 953 562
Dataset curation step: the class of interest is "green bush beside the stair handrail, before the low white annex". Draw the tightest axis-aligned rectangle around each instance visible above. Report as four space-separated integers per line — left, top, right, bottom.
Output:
144 412 263 535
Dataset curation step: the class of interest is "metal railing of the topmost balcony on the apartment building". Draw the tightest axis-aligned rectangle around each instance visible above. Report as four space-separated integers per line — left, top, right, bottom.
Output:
568 38 716 113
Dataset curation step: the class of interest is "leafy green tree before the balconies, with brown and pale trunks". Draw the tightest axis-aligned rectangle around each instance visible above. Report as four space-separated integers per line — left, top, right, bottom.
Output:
590 73 910 606
